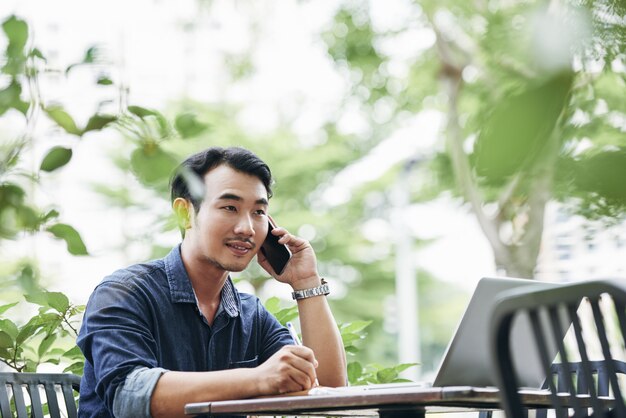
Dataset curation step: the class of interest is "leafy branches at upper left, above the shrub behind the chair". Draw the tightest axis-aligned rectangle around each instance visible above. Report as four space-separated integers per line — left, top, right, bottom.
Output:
0 16 103 251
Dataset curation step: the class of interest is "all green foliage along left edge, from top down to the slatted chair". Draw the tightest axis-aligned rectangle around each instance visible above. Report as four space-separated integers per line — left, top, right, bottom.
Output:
0 16 116 373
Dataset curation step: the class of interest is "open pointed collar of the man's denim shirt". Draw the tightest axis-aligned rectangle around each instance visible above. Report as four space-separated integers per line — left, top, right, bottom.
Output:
164 245 241 317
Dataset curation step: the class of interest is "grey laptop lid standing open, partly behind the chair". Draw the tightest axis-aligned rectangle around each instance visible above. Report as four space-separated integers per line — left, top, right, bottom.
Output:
433 277 560 388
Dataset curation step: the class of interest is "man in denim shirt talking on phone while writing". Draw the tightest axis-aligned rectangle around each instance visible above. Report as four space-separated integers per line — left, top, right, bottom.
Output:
78 148 346 417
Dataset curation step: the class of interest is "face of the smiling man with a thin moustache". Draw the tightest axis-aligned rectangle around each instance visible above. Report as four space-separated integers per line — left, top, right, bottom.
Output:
185 165 268 271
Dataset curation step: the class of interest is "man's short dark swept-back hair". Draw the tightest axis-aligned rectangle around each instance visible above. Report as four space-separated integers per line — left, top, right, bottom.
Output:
170 147 272 213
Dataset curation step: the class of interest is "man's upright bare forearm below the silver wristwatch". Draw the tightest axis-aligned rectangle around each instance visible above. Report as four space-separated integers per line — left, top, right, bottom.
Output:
298 286 347 387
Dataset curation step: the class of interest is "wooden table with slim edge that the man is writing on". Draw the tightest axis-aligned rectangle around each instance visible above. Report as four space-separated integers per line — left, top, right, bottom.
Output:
185 386 549 418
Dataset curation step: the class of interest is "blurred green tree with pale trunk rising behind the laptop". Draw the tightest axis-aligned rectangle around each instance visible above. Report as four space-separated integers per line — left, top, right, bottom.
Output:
322 0 626 278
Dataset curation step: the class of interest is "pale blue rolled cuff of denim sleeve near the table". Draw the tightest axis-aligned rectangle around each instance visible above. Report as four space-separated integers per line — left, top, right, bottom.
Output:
113 367 167 418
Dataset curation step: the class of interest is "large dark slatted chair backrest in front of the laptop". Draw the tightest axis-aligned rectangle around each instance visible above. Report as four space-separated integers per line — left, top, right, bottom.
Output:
491 281 626 418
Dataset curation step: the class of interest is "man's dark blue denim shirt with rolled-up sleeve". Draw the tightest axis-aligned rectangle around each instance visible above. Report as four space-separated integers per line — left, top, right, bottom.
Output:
77 246 293 417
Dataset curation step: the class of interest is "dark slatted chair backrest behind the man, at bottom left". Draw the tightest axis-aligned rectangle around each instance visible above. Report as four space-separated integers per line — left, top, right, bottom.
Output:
0 373 80 418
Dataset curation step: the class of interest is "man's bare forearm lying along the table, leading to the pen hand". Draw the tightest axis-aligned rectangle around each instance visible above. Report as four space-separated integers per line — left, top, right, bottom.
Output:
150 369 261 418
